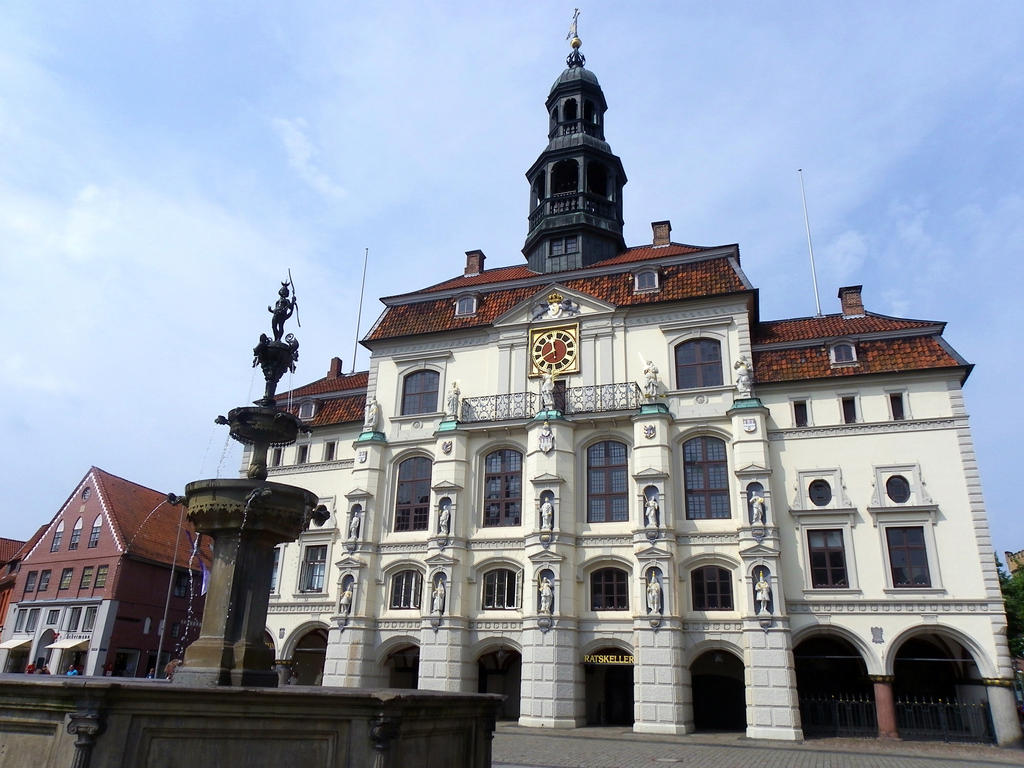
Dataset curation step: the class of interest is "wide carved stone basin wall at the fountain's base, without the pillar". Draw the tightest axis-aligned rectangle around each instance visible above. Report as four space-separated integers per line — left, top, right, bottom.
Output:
0 675 502 768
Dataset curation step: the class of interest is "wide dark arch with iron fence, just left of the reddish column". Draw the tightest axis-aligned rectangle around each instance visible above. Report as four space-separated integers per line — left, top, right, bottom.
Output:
793 635 879 737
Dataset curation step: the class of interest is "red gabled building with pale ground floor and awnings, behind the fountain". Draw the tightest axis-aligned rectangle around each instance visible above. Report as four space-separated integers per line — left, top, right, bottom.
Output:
0 467 211 677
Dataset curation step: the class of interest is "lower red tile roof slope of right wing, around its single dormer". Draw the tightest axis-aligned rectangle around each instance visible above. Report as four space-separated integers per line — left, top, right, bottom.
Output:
754 336 965 383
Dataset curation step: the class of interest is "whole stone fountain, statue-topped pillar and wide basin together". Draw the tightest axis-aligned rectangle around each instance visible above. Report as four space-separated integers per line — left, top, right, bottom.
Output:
0 281 501 768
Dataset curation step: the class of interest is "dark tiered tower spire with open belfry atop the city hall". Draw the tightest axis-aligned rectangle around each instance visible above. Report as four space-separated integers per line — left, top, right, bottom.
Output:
522 27 626 272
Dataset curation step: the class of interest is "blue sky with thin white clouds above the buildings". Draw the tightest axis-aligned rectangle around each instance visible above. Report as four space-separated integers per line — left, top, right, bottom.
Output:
0 0 1024 552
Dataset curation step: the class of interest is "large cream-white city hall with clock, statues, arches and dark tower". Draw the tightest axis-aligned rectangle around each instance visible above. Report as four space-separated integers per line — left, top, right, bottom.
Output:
258 41 1020 742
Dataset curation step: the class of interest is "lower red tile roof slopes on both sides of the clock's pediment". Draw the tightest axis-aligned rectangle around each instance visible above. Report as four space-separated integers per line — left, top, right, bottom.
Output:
367 257 748 341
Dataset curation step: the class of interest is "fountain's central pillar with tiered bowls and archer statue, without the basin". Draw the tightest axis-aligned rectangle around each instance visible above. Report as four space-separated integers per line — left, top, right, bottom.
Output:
174 281 328 687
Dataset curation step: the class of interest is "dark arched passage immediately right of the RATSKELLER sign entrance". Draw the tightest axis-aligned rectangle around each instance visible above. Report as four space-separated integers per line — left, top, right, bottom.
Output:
690 650 746 731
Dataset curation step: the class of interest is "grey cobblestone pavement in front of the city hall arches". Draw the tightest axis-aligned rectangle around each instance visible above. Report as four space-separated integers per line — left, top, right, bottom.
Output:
493 723 1024 768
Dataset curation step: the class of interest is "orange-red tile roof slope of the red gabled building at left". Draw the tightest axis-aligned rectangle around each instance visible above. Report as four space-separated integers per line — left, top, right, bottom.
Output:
91 467 211 567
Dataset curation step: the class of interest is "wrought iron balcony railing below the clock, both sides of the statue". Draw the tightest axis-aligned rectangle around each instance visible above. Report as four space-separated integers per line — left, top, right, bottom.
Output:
459 381 643 424
